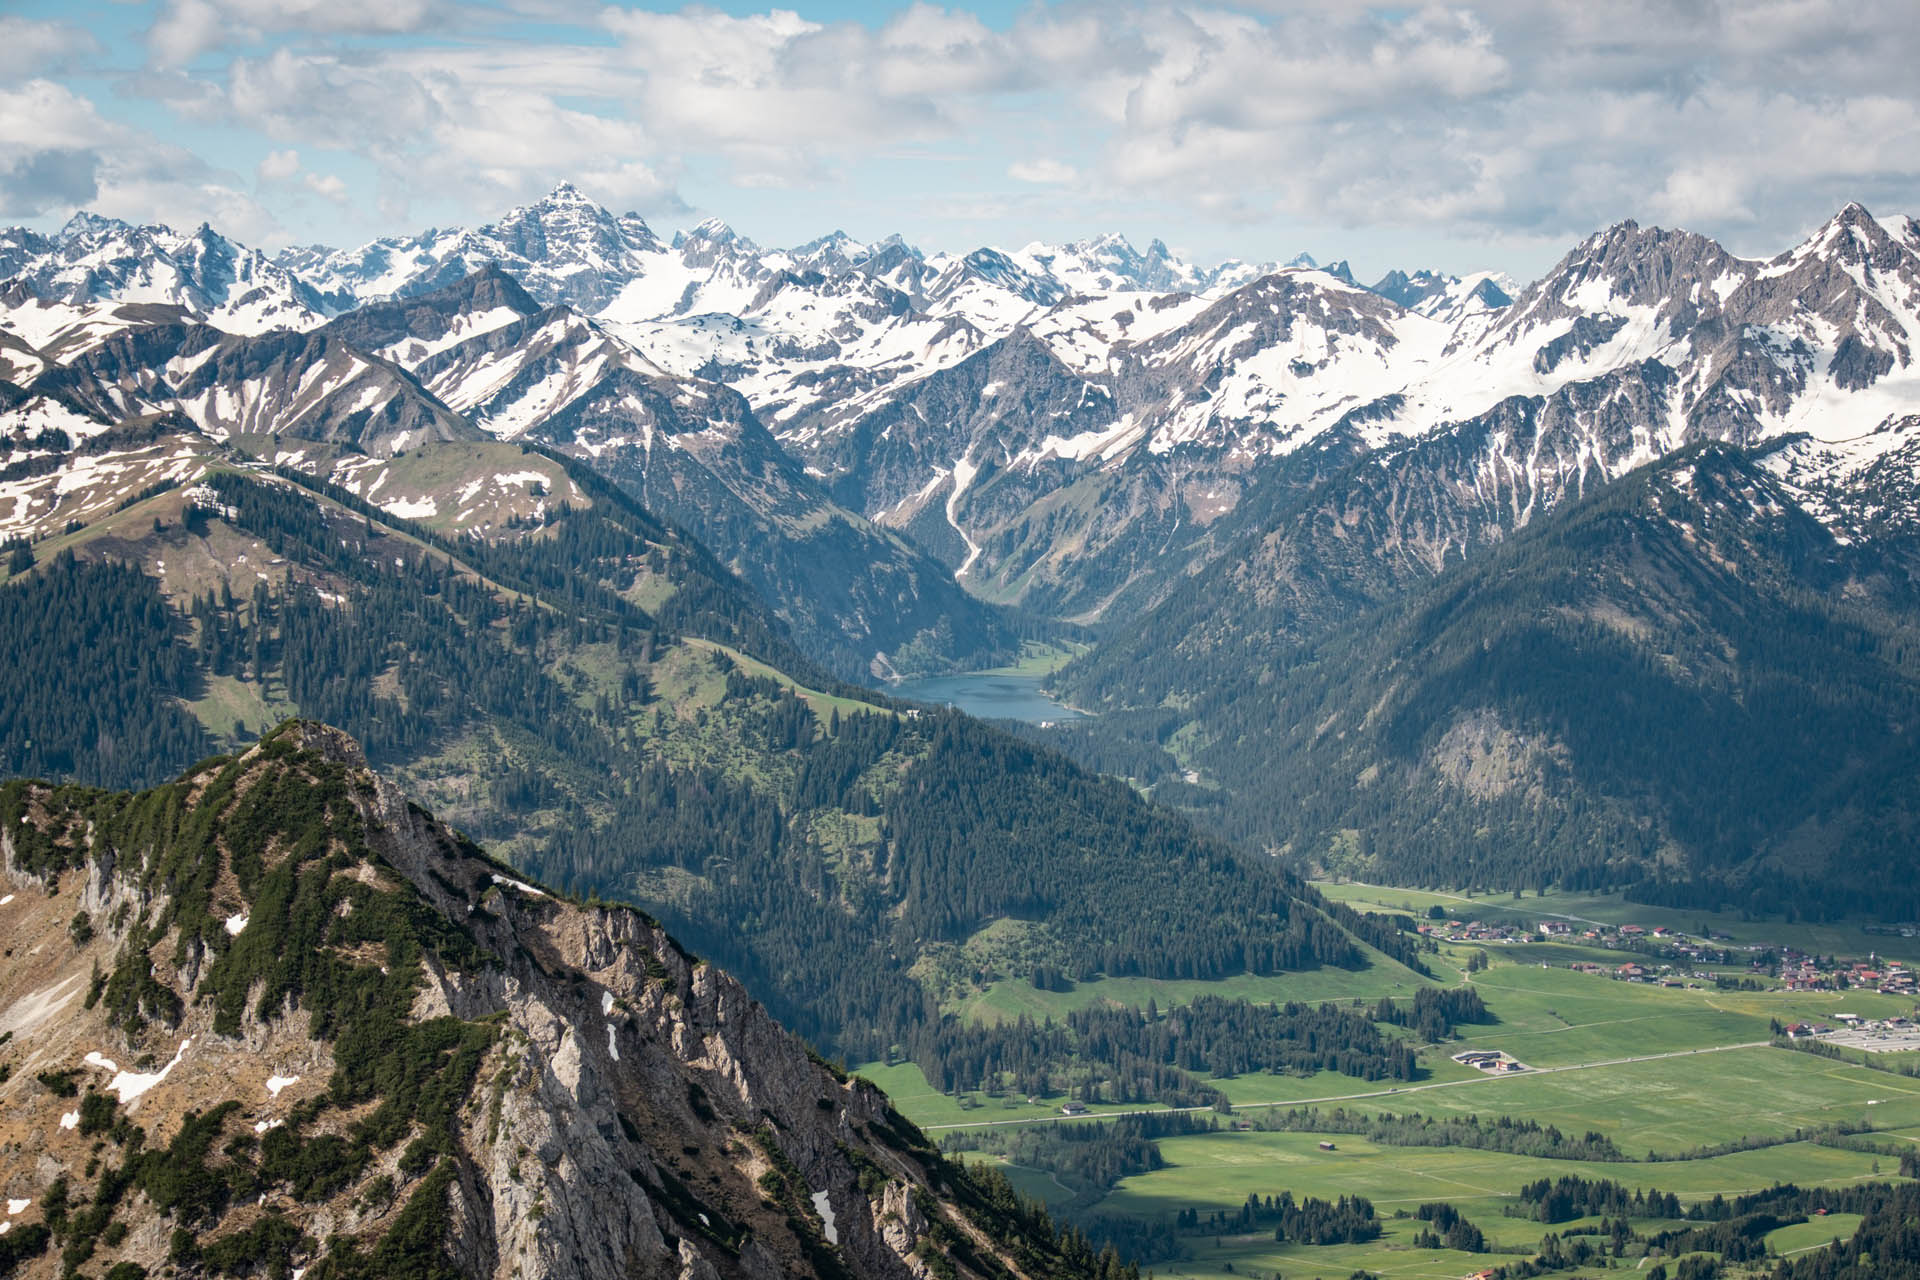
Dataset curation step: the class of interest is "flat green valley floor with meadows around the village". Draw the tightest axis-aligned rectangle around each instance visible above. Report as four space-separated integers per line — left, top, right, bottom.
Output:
862 883 1920 1280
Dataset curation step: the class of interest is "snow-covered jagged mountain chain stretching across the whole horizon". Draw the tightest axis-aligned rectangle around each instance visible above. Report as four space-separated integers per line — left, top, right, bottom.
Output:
11 186 1920 637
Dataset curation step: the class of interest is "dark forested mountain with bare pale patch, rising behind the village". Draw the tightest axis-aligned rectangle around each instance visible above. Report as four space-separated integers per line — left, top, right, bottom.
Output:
1052 445 1920 919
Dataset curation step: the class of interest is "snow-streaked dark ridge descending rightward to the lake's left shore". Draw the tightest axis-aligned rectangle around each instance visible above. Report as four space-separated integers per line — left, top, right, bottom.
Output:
321 271 1020 679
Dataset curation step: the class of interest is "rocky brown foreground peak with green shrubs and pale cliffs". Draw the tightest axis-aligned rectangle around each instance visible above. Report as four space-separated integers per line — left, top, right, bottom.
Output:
0 723 1081 1280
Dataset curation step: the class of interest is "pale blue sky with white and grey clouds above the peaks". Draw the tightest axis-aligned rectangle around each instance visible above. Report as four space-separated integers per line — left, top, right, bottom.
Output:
0 0 1920 280
